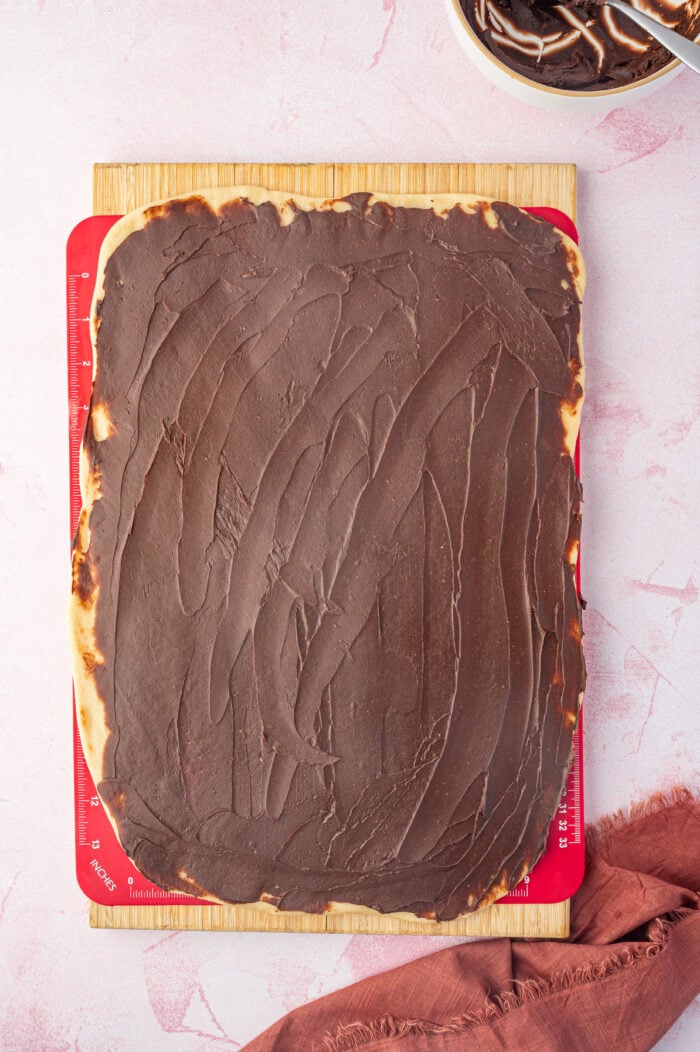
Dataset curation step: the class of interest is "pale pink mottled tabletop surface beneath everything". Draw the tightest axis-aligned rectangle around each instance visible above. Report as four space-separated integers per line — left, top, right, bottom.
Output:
0 0 700 1052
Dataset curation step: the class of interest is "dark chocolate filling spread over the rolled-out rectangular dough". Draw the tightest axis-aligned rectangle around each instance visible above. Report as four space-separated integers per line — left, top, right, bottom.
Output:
80 195 584 919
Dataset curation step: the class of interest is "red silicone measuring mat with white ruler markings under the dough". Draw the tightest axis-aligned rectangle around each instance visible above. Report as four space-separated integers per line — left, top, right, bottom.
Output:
66 208 584 906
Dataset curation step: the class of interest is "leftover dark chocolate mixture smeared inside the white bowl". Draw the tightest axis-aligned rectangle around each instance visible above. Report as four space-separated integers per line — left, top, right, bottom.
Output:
460 0 700 92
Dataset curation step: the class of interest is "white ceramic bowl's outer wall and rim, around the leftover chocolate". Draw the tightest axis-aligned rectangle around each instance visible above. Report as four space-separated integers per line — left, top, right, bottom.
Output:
445 0 680 114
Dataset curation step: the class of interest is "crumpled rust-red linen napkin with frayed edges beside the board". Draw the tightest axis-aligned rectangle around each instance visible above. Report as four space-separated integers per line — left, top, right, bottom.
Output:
245 789 700 1052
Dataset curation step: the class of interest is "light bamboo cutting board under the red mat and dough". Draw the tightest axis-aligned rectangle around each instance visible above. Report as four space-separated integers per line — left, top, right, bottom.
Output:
89 164 576 938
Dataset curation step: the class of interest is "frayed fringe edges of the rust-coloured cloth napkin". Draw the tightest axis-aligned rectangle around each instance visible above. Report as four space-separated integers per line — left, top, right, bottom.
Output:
316 787 699 1052
